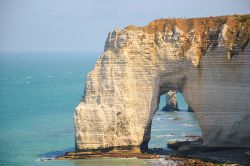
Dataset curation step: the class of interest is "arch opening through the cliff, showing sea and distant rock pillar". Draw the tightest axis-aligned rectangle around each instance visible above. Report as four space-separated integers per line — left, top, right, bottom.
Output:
148 90 202 149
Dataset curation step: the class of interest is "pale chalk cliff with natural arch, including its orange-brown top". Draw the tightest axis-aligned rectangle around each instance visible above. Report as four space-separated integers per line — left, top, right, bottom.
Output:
74 15 250 150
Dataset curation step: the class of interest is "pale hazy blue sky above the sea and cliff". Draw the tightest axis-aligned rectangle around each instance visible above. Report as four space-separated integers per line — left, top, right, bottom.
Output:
0 0 250 52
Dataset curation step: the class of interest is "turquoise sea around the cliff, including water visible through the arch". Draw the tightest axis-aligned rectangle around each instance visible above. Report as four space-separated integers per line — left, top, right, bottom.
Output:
0 52 201 166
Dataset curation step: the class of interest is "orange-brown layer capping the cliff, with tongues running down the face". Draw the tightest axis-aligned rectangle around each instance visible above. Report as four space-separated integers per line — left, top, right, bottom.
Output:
126 15 250 65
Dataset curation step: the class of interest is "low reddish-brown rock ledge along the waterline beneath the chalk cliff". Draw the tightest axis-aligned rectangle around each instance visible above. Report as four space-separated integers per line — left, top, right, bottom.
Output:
56 152 245 166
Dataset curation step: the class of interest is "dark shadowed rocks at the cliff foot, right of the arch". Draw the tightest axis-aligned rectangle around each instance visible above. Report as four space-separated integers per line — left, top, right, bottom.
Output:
168 139 250 166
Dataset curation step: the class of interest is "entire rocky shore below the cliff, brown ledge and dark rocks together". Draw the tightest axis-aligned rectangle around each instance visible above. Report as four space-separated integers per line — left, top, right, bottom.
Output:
56 140 250 166
